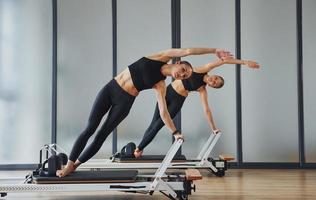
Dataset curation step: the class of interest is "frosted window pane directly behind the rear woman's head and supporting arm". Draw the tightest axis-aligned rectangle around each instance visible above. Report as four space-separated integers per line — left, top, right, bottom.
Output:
181 0 236 157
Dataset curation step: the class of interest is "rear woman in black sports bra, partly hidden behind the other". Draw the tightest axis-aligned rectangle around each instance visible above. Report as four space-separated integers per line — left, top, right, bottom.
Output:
134 57 259 158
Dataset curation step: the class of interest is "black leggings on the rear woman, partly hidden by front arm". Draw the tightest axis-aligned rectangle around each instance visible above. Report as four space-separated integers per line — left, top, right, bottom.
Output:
138 84 186 150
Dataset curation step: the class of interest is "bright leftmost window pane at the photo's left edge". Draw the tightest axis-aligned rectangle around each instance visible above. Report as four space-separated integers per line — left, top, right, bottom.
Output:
0 0 52 164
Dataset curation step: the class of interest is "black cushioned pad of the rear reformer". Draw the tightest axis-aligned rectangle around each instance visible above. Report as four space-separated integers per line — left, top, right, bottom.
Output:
118 155 186 162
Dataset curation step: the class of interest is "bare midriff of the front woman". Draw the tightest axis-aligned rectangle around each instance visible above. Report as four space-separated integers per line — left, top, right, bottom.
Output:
114 68 139 97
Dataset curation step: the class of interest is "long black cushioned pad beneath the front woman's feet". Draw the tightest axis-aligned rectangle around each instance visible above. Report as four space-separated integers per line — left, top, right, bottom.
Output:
33 170 138 183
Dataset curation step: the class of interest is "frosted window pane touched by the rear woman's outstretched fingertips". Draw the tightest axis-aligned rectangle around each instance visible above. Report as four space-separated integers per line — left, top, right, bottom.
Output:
241 0 298 162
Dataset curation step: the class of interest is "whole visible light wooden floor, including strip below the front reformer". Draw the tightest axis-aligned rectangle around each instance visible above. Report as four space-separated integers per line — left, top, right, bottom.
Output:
0 169 316 200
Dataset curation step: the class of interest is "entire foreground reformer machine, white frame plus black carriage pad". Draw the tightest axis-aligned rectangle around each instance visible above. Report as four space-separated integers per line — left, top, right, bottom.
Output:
0 139 202 199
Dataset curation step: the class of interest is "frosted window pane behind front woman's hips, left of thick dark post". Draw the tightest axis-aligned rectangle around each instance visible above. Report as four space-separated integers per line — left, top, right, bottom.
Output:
117 0 171 154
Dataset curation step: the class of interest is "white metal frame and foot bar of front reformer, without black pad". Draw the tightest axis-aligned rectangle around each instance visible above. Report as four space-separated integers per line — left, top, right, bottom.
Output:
0 139 200 199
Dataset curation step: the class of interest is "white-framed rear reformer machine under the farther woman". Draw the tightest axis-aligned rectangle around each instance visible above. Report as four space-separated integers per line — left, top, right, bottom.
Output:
80 132 234 176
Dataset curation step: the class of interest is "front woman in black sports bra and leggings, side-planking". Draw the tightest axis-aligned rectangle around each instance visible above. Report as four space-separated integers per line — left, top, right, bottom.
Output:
56 48 230 177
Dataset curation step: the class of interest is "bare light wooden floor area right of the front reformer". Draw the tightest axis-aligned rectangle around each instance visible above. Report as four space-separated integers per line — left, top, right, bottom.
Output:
198 169 316 200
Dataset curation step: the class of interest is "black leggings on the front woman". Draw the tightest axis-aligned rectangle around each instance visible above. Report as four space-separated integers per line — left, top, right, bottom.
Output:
69 79 135 163
